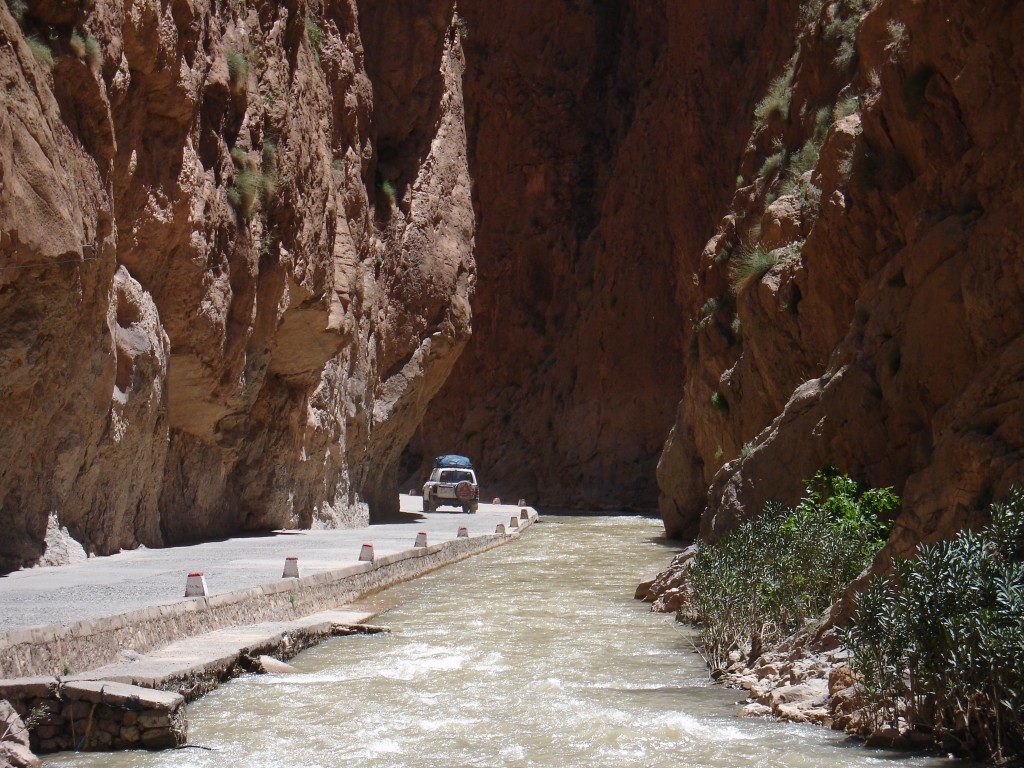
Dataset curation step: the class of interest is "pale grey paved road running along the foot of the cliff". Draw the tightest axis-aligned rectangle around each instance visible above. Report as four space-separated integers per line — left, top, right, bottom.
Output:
0 496 519 632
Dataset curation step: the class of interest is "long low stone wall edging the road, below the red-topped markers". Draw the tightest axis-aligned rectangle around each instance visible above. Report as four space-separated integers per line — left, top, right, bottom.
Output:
0 515 536 679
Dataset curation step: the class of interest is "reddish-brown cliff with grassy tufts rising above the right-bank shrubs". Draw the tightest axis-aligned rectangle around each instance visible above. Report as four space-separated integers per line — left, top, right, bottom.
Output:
658 0 1024 555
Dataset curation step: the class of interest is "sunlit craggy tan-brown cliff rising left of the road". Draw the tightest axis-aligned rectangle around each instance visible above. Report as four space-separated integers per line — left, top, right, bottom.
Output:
0 0 475 571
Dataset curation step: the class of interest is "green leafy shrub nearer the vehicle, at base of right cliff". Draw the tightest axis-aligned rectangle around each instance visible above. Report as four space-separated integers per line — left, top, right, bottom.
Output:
689 467 899 667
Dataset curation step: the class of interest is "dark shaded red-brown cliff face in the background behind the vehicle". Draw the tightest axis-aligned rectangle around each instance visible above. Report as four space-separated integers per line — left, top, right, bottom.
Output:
404 0 796 509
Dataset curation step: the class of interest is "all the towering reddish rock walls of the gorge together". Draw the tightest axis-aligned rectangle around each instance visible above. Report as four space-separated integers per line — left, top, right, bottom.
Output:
0 0 1024 757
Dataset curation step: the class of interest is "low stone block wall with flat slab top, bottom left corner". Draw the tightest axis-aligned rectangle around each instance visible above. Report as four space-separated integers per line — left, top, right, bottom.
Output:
0 677 187 754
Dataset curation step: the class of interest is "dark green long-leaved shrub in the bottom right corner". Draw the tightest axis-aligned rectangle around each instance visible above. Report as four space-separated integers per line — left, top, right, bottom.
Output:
843 487 1024 762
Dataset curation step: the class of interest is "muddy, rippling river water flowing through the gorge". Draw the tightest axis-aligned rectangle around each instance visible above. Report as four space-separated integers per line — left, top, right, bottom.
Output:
46 515 953 768
